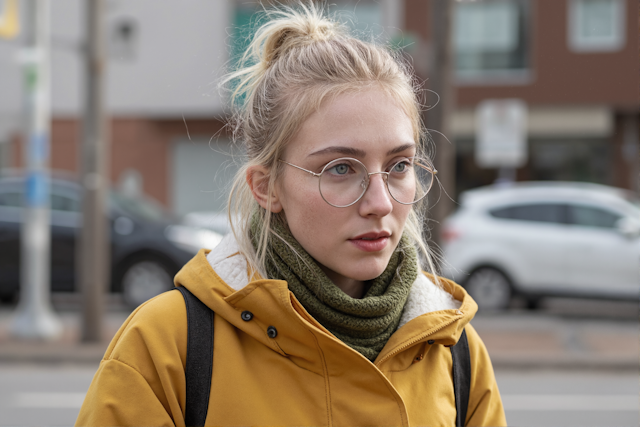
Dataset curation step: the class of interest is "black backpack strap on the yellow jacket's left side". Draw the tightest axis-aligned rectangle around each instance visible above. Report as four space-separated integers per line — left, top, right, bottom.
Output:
175 286 214 427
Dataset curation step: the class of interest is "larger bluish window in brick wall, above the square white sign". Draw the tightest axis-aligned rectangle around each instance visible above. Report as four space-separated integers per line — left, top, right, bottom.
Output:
453 0 529 80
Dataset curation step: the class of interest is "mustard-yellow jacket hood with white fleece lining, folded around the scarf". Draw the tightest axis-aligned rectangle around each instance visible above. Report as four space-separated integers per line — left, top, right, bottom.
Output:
175 234 477 365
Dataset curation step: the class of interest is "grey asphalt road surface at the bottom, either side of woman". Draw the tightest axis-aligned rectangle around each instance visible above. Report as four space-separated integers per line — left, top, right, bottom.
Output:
0 364 640 427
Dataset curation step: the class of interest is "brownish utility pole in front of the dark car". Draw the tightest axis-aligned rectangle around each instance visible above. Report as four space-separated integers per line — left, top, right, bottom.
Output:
76 0 111 342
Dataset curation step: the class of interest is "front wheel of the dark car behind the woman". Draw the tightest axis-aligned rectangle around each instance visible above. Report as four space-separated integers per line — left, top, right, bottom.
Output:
122 260 173 307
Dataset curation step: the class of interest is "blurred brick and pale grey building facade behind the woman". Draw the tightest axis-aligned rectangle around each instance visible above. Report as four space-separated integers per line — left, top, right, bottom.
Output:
0 0 640 214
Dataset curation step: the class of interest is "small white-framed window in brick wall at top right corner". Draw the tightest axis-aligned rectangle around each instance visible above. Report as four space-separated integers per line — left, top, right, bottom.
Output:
568 0 625 52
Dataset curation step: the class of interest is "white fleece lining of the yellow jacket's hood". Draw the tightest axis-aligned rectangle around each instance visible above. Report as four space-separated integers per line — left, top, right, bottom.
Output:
207 234 462 328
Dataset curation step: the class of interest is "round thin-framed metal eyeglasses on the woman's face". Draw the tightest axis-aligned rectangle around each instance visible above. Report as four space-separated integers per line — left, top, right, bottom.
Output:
280 157 438 208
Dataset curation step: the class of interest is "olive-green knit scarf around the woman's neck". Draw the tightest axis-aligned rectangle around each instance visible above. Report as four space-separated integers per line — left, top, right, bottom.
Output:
251 215 418 362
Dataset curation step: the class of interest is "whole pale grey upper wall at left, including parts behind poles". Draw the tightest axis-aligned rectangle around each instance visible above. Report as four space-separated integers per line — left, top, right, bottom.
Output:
0 0 232 128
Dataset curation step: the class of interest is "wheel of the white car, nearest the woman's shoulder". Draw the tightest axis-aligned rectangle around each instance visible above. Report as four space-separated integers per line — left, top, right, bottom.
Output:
465 267 511 311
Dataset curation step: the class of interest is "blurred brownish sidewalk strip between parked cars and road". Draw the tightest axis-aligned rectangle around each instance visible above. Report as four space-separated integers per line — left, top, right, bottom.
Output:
0 302 640 370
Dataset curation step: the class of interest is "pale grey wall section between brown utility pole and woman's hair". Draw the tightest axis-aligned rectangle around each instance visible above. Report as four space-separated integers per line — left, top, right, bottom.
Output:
102 0 232 116
